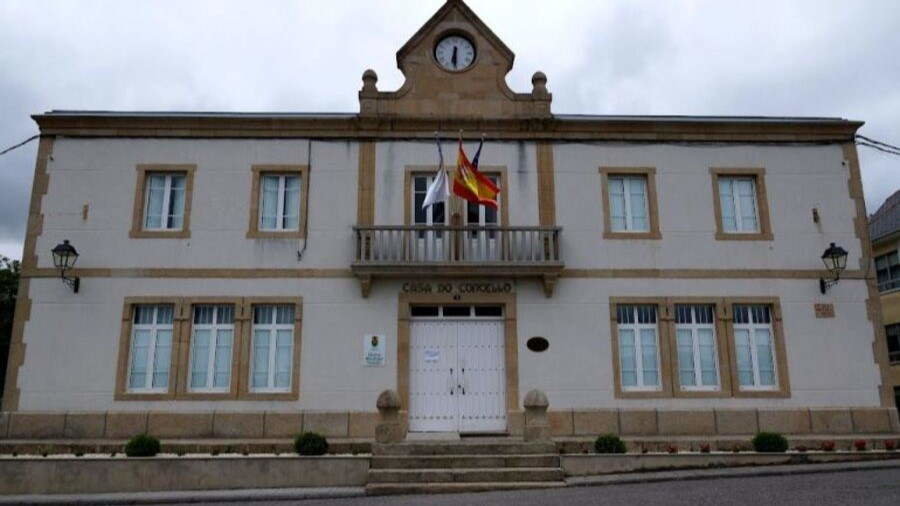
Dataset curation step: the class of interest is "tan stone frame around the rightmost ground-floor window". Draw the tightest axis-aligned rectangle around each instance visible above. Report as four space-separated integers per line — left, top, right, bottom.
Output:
724 297 791 398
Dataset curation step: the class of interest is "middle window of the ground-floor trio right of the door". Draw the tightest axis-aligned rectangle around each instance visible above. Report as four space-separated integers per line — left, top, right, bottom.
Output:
675 304 719 390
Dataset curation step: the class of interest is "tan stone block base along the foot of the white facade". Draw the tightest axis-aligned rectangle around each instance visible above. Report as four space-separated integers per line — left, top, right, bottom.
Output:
0 408 900 440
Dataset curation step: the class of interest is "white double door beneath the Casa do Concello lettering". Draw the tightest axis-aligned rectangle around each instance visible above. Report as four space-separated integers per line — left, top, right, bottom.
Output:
409 319 506 433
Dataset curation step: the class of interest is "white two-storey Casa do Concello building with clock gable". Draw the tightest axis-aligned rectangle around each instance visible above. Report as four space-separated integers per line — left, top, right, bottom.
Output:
3 0 900 437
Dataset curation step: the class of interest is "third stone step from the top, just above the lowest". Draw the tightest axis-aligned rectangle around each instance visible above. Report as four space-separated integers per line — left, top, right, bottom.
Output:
369 467 565 483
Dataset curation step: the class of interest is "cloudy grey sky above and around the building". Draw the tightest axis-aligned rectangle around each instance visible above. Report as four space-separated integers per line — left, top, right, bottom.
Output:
0 0 900 258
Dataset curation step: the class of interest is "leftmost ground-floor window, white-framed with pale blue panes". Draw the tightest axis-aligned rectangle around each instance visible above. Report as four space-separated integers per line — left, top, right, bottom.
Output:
128 304 174 393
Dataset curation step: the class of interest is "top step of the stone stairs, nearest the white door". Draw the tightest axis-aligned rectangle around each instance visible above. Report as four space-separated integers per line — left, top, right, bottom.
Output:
372 441 558 455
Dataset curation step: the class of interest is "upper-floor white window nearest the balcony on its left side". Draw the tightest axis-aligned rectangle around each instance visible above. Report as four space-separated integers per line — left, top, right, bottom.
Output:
259 174 300 232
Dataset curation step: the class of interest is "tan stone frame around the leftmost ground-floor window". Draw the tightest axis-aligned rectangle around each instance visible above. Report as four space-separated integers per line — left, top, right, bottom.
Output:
114 297 184 401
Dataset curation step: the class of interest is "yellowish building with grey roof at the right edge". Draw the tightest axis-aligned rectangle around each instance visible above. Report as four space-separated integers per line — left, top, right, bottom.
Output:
869 191 900 416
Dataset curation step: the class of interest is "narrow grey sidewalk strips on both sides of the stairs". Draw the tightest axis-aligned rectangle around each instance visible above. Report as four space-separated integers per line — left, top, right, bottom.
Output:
0 460 900 505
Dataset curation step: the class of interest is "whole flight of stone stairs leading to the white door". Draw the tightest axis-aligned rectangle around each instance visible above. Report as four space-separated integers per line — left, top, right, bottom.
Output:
366 438 565 495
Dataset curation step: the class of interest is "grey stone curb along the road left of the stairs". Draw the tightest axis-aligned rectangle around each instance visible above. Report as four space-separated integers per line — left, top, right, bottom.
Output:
0 487 366 505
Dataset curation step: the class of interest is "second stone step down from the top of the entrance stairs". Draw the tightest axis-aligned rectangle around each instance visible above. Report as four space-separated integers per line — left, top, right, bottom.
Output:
371 453 559 469
